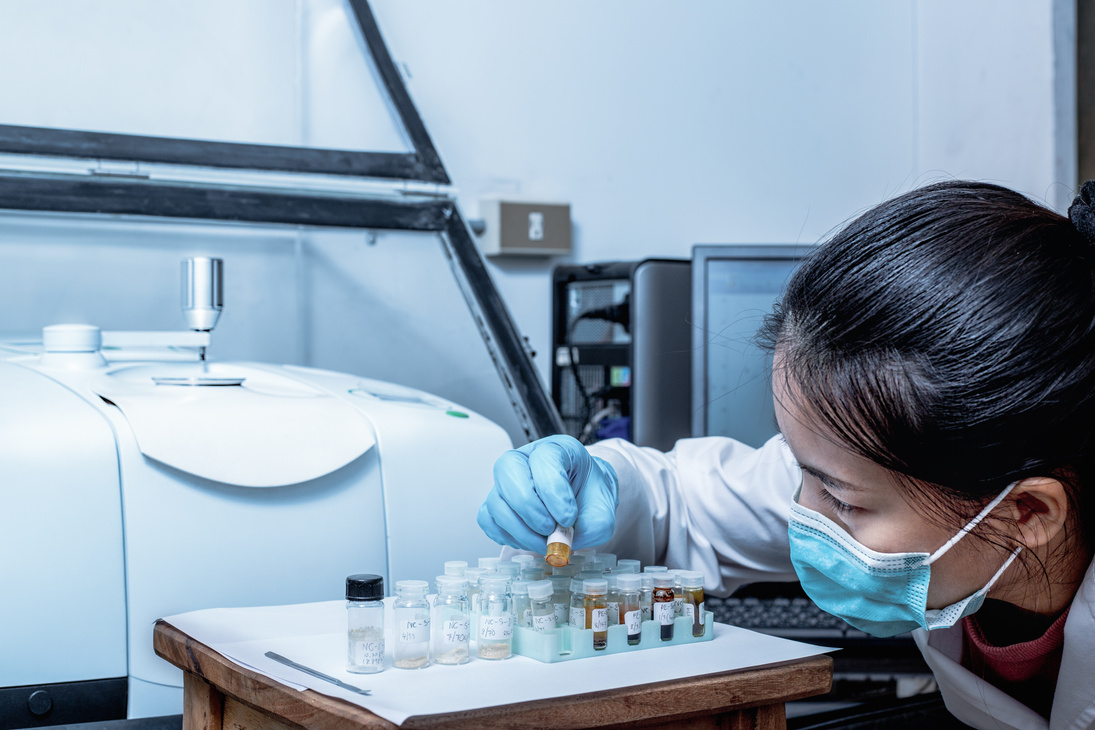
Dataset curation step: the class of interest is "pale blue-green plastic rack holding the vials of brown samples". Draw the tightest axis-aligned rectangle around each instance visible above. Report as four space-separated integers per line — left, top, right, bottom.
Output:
514 611 715 663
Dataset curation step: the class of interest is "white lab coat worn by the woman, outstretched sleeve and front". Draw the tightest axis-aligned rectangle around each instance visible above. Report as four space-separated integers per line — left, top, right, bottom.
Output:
589 437 1095 730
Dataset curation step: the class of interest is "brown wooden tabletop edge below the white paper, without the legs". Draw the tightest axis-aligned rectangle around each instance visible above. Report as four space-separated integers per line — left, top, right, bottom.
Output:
153 619 832 730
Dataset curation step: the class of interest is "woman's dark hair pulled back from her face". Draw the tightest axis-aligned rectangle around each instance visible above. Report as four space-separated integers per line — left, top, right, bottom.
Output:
760 181 1095 545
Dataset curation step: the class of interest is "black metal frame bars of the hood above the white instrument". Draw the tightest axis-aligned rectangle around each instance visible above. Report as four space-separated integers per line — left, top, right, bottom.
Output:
0 0 562 439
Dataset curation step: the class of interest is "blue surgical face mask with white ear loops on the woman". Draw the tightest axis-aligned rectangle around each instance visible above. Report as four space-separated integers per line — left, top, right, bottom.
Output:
787 483 1023 637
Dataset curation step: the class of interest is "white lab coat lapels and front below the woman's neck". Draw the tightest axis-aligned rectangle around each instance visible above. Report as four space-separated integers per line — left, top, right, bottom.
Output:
913 553 1095 730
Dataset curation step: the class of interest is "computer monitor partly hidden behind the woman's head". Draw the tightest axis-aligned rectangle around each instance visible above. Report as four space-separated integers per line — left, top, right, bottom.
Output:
692 244 812 447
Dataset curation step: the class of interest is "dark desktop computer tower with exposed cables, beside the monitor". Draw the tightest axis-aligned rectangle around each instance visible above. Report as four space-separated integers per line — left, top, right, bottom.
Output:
552 259 692 451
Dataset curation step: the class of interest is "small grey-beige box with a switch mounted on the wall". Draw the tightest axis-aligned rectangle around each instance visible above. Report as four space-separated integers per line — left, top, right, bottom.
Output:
480 199 570 256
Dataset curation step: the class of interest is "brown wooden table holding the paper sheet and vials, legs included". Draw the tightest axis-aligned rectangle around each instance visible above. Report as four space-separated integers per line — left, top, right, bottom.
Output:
153 621 832 730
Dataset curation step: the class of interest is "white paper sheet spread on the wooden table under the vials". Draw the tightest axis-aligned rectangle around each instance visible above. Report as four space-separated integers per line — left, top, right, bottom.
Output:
164 599 832 725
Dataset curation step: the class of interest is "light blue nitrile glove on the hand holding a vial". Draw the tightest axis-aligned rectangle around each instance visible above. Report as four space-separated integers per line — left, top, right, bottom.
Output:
477 436 620 555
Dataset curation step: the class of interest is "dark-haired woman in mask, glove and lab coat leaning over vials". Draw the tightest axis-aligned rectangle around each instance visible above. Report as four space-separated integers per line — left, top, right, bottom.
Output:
479 182 1095 730
